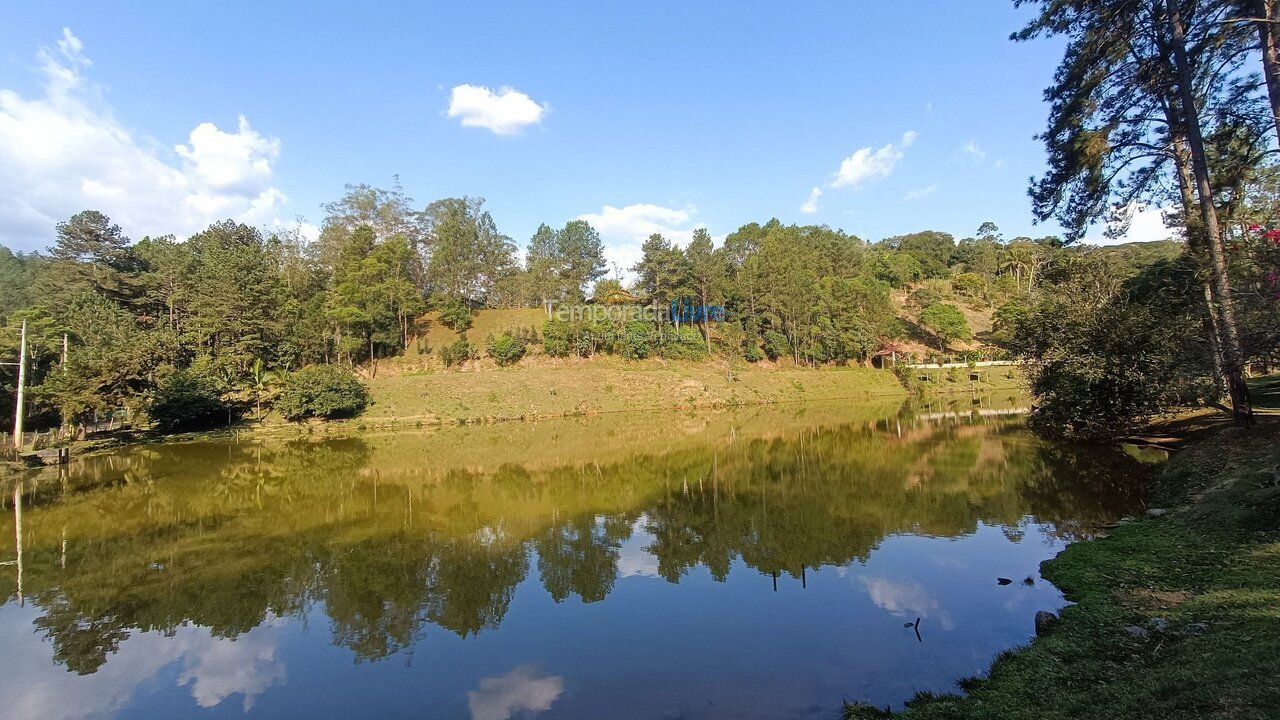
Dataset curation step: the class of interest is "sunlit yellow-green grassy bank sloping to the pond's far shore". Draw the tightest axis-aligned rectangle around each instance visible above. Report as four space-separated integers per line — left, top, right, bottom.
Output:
360 357 1020 424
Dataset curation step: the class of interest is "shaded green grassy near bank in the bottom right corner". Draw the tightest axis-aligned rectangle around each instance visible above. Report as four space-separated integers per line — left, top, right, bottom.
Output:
846 380 1280 720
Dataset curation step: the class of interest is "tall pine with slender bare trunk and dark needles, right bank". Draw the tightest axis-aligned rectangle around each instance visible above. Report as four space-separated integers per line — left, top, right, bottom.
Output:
1014 0 1256 424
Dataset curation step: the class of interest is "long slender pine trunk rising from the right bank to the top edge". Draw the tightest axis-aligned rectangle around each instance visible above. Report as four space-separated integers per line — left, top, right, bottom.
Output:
1165 0 1253 427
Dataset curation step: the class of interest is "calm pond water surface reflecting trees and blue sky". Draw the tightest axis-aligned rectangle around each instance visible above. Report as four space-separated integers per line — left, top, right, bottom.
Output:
0 398 1144 720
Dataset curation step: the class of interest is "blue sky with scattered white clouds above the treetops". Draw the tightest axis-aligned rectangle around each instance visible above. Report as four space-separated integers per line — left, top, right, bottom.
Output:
0 0 1164 265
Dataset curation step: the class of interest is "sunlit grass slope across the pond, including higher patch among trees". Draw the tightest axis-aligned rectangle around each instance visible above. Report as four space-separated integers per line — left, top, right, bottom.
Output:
322 302 1021 425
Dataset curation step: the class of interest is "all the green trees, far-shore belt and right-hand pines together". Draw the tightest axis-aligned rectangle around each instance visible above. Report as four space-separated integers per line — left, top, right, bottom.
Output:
0 0 1280 434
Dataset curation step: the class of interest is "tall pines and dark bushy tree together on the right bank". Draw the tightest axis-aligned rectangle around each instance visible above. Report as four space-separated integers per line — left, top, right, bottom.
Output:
1012 0 1280 436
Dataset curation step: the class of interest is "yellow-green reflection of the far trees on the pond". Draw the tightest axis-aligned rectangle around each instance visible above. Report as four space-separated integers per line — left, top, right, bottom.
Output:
3 419 1142 673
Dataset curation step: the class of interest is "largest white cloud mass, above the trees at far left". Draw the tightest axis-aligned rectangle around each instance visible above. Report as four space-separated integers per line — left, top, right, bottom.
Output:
0 29 287 249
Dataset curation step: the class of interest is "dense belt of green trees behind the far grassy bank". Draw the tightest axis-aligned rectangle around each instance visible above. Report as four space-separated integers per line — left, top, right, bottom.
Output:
0 167 1277 438
